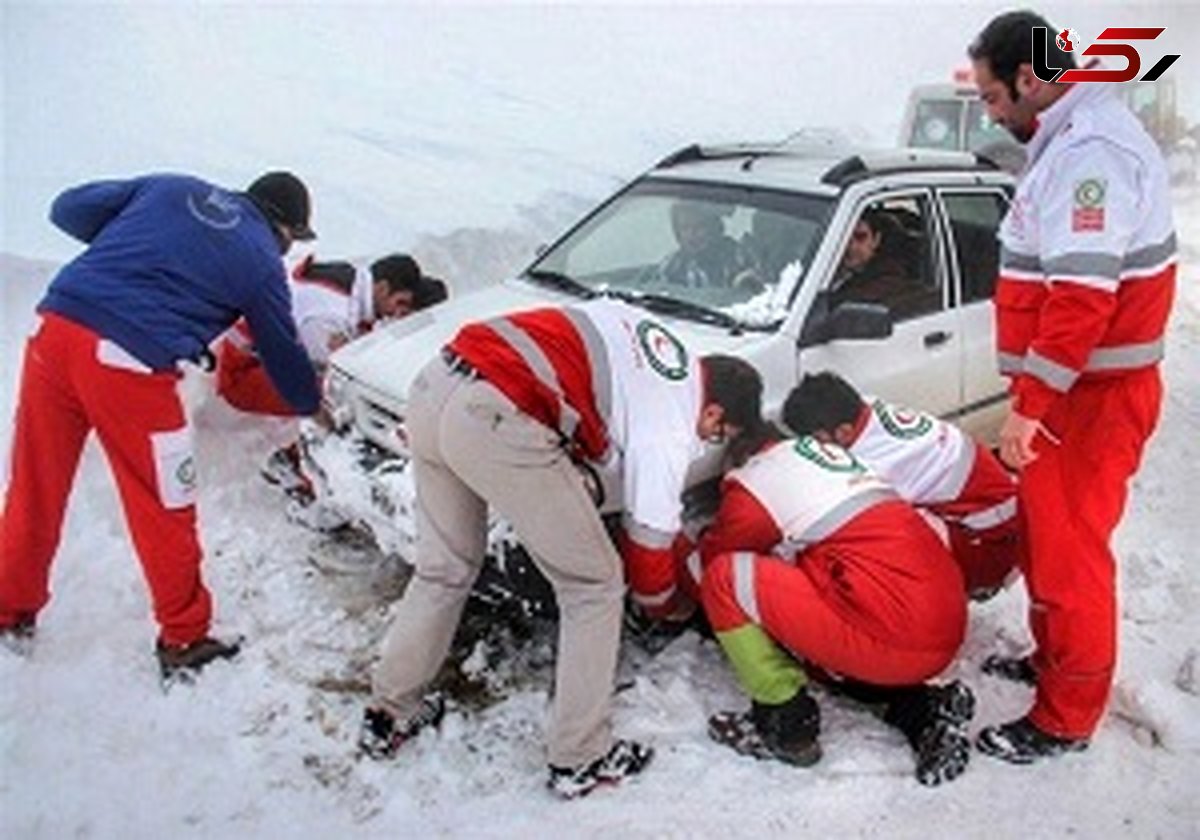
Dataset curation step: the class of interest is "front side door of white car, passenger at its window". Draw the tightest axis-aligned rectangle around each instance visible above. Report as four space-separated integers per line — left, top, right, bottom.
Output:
798 190 962 414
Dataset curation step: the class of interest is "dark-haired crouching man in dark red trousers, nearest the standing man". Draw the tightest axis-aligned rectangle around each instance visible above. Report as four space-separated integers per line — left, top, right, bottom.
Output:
782 371 1022 595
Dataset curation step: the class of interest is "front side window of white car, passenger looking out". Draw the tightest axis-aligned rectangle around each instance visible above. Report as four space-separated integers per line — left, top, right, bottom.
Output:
829 196 943 322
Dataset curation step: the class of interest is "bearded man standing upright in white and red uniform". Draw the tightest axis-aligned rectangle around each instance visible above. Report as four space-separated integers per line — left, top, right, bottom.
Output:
968 12 1176 763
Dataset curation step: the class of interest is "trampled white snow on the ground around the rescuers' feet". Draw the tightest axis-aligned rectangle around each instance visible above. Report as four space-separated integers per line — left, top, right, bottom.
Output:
0 205 1200 838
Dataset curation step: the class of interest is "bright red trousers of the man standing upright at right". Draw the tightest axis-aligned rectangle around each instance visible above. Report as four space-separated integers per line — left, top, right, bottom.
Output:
1020 367 1163 738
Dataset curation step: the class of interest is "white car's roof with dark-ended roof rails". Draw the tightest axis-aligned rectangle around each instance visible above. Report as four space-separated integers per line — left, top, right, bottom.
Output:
648 142 1006 197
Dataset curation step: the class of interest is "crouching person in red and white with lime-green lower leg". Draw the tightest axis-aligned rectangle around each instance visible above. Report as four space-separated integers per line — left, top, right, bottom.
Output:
695 424 974 785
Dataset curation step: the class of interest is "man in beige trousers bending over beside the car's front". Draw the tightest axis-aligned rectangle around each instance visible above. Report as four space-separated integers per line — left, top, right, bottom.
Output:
360 300 761 797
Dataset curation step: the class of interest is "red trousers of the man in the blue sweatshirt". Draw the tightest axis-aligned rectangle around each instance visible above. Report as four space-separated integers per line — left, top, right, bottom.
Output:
0 313 212 644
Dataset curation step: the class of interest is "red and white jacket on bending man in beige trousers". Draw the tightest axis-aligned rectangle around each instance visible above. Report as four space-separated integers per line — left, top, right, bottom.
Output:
449 300 703 614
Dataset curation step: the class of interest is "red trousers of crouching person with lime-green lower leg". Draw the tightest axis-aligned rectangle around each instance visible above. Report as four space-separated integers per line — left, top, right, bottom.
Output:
701 502 966 685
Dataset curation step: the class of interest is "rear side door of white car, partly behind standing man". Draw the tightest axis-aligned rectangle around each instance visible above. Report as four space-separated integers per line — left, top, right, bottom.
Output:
938 186 1009 439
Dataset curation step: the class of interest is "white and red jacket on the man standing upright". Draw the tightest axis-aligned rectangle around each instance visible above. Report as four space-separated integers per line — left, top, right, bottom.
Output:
995 84 1176 418
